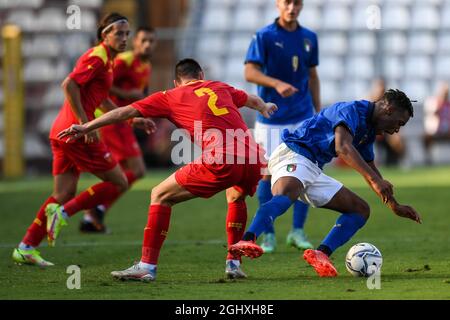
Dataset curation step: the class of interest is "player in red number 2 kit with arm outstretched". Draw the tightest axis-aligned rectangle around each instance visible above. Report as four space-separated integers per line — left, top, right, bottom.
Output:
59 59 277 281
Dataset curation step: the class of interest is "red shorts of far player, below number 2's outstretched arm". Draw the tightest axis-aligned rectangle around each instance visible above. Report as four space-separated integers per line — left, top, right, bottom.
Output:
100 122 142 162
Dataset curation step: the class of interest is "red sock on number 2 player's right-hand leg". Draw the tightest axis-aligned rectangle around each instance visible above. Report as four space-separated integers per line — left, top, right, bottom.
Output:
226 200 247 260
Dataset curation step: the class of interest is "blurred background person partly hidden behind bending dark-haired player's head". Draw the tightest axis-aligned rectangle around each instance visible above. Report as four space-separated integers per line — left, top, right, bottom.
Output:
368 78 406 166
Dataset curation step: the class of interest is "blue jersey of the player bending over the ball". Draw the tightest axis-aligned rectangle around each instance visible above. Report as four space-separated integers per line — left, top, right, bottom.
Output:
281 100 376 168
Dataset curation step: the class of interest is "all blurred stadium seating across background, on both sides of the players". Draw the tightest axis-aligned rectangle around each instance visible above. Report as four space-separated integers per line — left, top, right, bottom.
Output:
0 0 450 168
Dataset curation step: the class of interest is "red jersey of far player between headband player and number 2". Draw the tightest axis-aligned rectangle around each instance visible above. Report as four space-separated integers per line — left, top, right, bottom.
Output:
111 51 152 107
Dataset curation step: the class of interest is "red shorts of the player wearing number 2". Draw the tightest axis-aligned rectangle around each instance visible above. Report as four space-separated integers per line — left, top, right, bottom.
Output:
175 163 263 198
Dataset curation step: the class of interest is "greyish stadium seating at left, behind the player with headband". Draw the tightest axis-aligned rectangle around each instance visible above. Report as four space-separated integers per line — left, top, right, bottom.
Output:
0 0 99 168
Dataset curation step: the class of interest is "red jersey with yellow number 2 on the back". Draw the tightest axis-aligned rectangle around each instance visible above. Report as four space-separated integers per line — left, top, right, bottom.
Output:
131 80 260 162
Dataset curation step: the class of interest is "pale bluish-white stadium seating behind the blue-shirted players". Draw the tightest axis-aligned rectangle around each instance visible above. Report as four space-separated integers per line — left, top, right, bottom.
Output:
180 0 450 165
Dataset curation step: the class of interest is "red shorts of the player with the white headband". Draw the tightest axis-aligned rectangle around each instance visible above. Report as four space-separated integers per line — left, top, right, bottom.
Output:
50 139 117 176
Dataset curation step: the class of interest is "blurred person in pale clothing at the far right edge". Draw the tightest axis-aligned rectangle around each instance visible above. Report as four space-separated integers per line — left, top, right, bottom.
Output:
423 82 450 164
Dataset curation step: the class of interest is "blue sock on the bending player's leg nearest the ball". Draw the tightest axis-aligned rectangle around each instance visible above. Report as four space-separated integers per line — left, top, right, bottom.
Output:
318 213 367 255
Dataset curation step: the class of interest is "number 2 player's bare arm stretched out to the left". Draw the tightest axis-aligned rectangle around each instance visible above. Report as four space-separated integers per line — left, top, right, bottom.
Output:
58 106 141 142
